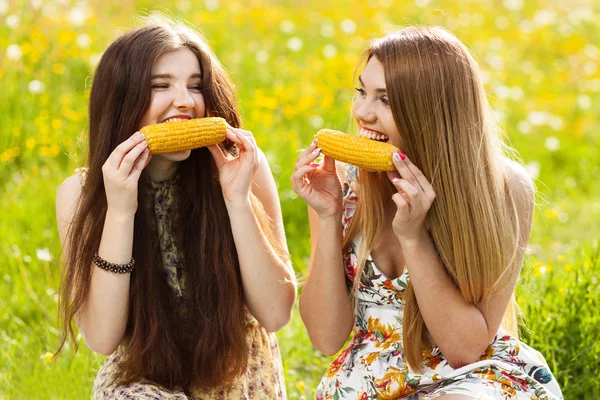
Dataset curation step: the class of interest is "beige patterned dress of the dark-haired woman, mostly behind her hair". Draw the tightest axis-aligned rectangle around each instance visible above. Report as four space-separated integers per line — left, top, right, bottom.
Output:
77 168 286 400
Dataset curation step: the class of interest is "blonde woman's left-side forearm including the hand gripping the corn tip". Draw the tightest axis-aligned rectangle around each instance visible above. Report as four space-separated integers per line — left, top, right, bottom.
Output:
292 142 354 355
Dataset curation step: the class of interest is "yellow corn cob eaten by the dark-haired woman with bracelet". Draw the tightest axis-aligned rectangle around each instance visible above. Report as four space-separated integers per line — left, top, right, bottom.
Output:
140 117 227 154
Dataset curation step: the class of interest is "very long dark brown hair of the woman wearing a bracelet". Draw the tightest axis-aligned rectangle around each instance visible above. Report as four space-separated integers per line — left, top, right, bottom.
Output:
57 17 281 389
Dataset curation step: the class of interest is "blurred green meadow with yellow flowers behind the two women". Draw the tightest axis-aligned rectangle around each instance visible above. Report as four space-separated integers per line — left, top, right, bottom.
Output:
0 0 600 399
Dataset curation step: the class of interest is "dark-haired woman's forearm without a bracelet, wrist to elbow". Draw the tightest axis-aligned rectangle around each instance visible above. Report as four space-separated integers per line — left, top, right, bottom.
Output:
227 199 296 332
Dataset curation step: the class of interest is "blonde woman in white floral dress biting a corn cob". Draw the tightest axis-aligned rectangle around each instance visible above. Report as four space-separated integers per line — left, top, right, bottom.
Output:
292 28 562 400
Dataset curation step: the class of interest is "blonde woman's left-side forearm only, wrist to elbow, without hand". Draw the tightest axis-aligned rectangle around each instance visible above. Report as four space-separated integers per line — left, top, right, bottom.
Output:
300 217 354 355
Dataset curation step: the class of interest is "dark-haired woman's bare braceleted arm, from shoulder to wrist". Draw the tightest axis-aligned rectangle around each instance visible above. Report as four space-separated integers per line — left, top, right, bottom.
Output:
56 134 148 355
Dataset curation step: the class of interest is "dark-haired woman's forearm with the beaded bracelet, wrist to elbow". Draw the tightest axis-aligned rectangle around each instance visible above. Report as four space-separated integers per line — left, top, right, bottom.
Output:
77 210 134 355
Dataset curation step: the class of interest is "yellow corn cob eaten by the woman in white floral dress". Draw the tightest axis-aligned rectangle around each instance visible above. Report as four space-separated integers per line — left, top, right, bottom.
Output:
315 129 400 171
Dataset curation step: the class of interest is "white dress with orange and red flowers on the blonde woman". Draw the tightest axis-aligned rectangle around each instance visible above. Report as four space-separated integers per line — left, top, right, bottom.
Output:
316 165 563 400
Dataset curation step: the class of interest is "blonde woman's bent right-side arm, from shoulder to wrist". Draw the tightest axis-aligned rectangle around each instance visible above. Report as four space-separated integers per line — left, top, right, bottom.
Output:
390 155 534 368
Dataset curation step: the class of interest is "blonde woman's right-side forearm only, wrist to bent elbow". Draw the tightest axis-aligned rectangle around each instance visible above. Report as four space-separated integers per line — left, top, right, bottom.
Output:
401 231 495 367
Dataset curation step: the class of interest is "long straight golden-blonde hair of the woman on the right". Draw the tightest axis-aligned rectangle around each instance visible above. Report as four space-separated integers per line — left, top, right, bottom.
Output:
342 27 519 371
